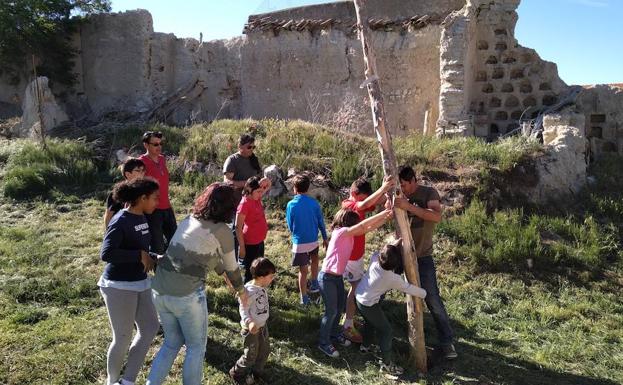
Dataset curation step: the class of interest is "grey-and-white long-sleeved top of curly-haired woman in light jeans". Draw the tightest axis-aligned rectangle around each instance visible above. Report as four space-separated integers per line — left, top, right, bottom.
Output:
152 216 243 297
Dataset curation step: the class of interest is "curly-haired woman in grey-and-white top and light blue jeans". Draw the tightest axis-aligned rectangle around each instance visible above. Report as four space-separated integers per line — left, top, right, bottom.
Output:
147 182 247 385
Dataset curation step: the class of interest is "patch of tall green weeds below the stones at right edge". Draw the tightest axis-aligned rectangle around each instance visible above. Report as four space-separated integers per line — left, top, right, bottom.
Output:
439 200 619 272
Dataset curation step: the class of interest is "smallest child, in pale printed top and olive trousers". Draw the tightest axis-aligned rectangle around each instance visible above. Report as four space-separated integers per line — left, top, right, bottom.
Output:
229 257 276 384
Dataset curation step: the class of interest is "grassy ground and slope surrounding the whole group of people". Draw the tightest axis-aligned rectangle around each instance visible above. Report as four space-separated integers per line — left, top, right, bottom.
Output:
0 121 623 384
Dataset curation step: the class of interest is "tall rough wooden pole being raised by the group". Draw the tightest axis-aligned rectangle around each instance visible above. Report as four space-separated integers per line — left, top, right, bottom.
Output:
353 0 427 373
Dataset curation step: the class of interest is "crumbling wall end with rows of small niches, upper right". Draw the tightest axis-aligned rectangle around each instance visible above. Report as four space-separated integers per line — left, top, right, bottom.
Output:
439 0 567 139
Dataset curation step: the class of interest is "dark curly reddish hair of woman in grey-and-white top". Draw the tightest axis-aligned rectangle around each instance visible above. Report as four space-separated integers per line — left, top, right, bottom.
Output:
193 182 236 223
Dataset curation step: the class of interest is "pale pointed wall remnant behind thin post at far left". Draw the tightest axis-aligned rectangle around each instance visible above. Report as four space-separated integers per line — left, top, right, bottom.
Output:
16 76 69 137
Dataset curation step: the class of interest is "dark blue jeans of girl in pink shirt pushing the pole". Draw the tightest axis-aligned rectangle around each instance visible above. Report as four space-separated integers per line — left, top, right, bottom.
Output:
318 271 346 345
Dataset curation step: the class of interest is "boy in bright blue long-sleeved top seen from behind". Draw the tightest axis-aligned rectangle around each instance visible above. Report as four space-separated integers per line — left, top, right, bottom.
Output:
286 175 328 305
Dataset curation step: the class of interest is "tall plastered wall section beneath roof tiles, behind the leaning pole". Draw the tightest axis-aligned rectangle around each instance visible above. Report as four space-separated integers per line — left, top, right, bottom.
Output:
242 25 440 134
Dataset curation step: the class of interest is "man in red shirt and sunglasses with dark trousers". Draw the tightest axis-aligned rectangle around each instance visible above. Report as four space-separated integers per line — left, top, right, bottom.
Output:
139 131 177 254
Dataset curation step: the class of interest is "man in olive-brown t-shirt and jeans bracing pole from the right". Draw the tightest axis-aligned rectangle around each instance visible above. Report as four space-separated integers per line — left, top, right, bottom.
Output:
394 166 457 359
